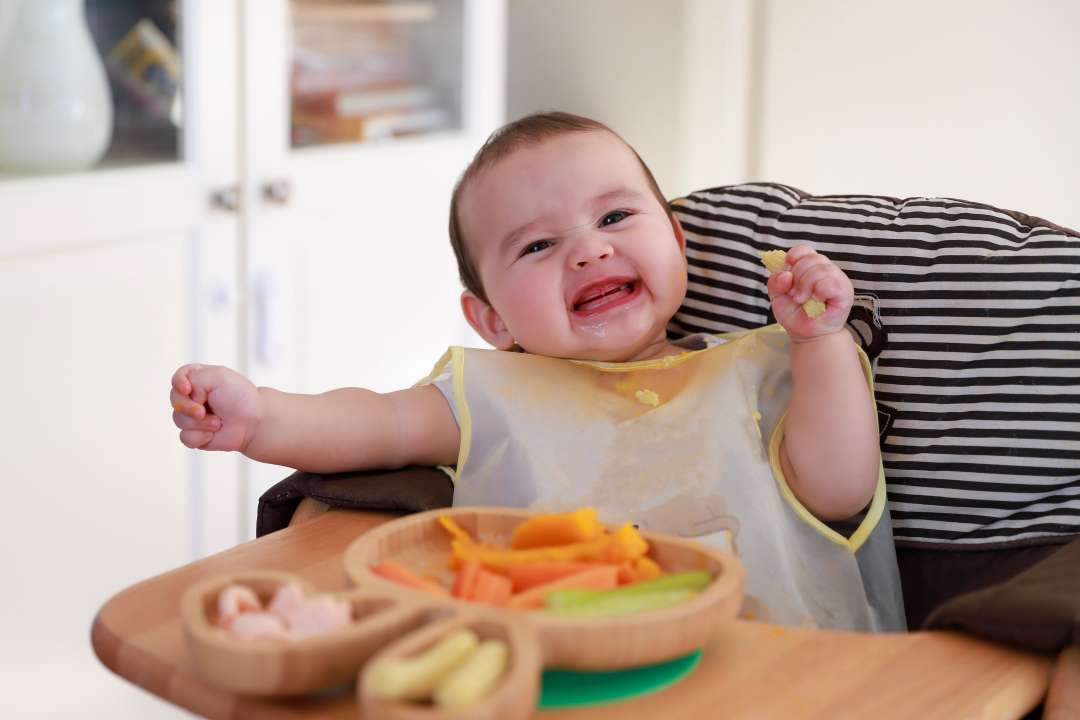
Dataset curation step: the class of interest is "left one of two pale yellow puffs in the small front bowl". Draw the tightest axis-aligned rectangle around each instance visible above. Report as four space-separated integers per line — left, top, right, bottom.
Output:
367 628 480 699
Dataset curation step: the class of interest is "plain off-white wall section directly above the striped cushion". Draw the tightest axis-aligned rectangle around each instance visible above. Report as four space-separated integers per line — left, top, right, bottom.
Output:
750 0 1080 228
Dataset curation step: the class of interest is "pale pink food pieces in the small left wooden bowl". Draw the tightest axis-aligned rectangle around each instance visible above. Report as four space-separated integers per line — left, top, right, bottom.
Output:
217 583 352 640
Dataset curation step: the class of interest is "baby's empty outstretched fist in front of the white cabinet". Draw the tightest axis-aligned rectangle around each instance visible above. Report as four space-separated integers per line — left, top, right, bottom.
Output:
168 365 259 450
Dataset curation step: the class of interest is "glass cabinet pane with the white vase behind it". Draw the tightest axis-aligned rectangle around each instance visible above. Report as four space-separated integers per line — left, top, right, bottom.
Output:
0 0 183 177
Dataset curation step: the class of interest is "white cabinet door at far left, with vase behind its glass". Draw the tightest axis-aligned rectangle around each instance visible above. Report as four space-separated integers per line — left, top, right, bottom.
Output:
0 0 239 717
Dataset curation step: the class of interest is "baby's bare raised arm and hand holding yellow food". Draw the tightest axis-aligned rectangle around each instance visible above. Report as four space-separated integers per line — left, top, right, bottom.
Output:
769 245 881 520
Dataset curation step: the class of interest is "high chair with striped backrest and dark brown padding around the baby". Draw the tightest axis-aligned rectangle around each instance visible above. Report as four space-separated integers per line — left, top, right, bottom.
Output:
257 184 1080 707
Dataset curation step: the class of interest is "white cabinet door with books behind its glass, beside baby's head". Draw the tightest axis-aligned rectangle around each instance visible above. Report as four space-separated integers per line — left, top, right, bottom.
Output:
235 0 504 508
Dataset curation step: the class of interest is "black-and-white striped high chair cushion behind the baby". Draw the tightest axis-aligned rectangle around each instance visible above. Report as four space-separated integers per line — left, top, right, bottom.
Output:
669 184 1080 547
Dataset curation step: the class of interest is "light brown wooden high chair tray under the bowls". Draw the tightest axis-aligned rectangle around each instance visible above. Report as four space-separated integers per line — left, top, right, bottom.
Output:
92 511 1051 720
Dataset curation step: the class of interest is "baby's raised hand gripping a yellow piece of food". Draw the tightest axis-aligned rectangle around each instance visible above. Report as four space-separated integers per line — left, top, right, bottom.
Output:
769 245 854 342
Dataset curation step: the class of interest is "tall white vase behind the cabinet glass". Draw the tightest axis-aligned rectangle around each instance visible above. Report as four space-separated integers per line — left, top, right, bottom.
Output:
0 0 112 172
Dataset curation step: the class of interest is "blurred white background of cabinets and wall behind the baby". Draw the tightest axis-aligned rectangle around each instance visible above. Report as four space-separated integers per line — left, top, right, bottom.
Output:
0 0 1080 717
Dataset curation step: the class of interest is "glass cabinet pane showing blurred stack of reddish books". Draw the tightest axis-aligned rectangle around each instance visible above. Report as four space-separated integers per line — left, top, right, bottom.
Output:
289 0 462 148
